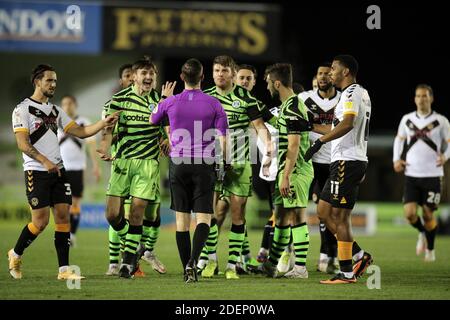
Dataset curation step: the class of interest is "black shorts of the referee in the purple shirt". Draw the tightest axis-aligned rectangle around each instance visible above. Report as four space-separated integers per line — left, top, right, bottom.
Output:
169 158 216 214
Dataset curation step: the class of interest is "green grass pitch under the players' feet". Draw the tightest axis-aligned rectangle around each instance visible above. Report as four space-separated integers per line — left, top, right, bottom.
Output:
0 208 450 300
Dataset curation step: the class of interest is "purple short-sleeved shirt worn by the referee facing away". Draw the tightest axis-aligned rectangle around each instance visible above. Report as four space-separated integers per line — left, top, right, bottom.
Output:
151 89 228 159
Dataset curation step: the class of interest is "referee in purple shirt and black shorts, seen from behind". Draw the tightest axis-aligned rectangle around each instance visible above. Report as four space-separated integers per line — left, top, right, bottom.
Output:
150 59 228 283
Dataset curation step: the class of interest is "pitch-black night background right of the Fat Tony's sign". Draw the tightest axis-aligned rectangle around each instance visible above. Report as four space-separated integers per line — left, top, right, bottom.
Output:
160 1 450 134
